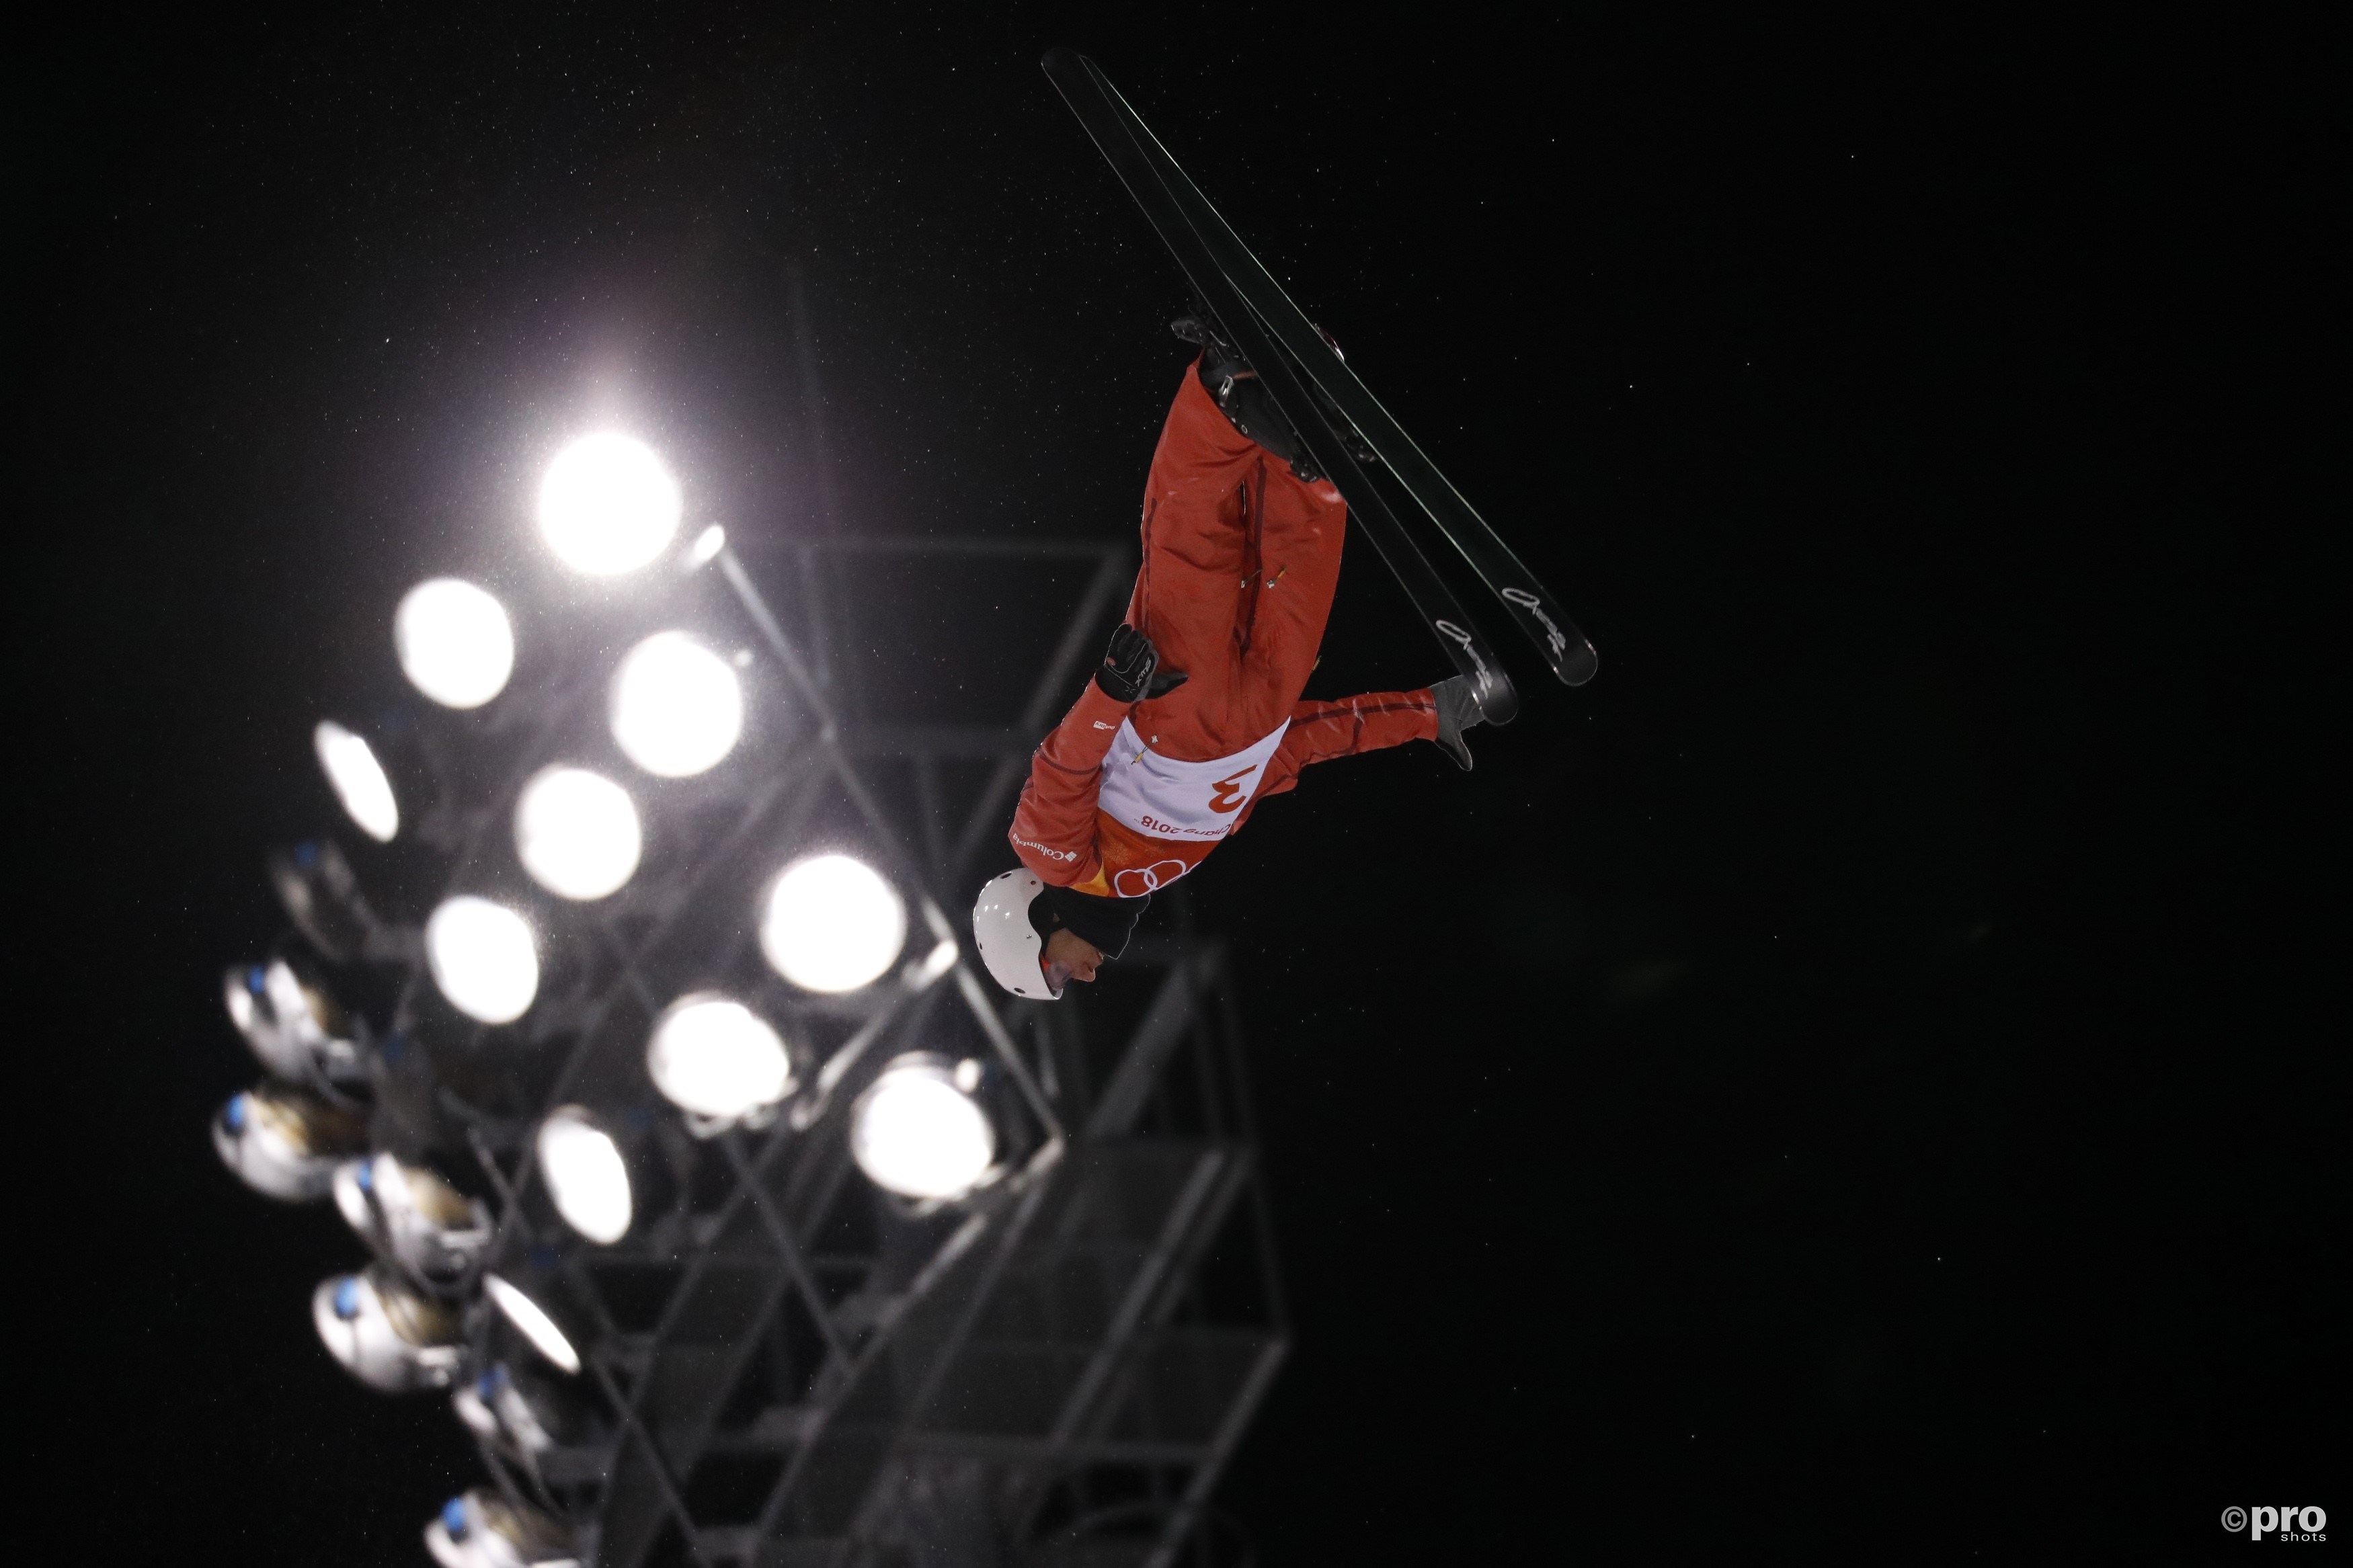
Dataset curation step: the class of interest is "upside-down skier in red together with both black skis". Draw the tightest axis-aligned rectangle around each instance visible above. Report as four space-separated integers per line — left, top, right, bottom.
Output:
972 49 1595 999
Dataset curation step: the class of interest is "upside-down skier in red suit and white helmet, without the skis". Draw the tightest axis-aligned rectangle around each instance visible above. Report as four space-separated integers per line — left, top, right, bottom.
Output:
974 327 1482 995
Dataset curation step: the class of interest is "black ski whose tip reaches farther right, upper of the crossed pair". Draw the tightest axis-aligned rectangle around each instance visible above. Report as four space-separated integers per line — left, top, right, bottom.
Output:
1045 49 1600 686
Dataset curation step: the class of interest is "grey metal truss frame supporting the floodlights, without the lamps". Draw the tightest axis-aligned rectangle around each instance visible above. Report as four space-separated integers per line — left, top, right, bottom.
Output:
353 538 1287 1568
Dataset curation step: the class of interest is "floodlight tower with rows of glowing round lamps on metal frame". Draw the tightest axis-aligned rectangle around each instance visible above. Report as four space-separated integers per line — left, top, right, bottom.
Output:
214 300 1287 1568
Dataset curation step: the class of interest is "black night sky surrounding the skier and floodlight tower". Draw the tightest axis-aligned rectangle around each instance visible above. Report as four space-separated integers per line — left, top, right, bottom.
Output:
9 5 2353 1563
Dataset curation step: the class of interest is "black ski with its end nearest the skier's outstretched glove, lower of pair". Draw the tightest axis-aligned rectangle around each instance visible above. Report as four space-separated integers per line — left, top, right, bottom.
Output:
1045 49 1520 724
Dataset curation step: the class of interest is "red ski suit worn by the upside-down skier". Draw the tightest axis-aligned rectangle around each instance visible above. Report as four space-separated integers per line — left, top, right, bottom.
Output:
1007 369 1438 898
